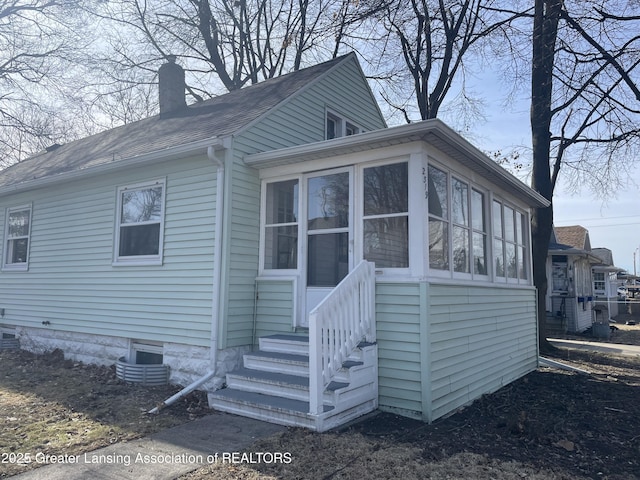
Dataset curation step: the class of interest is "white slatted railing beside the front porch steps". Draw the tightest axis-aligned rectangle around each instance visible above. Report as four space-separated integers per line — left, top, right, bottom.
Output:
309 260 376 415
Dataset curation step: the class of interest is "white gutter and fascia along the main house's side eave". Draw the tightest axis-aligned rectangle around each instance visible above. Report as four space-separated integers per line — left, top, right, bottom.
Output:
0 137 229 197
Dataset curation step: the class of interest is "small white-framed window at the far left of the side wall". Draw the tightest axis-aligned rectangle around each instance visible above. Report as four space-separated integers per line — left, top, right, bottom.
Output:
4 205 31 270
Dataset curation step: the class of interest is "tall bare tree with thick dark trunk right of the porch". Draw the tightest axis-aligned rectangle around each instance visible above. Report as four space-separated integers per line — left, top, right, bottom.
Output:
531 0 640 351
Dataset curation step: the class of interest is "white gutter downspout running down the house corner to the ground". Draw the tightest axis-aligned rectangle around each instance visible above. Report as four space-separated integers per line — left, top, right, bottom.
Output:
147 137 231 414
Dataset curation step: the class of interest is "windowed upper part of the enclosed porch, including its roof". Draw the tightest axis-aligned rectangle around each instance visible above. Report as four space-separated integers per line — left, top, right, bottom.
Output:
246 120 544 318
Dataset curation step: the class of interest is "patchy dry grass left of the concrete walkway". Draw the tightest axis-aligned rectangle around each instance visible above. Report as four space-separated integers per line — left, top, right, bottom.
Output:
0 351 204 477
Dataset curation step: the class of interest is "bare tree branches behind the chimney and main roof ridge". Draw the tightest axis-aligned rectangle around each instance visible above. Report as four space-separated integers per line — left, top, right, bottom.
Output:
85 0 384 100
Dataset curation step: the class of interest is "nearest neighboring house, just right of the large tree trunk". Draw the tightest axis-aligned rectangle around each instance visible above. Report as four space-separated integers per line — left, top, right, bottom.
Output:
547 225 601 333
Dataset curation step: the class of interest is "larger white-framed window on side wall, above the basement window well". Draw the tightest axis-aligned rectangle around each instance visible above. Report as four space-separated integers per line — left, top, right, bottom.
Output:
115 180 165 264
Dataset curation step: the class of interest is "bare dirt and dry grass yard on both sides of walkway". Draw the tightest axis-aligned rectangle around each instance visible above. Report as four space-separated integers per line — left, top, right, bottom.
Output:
0 317 640 480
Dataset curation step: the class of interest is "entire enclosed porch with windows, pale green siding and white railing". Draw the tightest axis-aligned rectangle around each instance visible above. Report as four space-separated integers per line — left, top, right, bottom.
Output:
209 120 546 429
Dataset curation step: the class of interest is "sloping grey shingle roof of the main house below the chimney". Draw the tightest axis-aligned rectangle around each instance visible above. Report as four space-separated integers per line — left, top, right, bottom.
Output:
0 53 354 191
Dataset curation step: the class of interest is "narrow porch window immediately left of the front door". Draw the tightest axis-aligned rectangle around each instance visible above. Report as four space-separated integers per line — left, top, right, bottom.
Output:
264 179 299 270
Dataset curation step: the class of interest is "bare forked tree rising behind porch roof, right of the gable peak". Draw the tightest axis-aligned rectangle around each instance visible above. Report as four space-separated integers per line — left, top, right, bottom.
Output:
376 0 520 121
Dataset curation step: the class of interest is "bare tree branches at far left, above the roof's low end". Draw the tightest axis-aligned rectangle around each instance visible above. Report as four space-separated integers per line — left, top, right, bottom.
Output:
0 0 92 167
